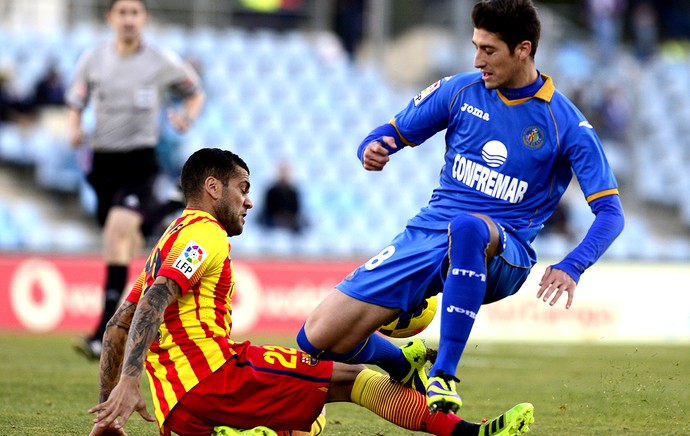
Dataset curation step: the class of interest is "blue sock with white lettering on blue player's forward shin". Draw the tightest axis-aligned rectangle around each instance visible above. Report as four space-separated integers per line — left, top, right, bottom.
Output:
430 215 490 376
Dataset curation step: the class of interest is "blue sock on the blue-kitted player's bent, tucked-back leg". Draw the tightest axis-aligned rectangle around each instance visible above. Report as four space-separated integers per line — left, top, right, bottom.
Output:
297 326 410 380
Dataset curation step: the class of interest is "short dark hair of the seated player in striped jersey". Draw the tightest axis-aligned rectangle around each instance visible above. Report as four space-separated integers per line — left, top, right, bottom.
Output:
180 148 249 199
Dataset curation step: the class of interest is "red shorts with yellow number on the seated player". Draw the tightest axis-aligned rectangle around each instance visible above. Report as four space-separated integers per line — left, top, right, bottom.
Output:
163 341 333 436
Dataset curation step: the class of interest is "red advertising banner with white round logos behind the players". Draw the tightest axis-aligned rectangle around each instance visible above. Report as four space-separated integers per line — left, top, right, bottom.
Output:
0 255 359 335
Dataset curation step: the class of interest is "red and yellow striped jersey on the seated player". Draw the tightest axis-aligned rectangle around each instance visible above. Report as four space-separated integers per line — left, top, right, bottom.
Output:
127 209 235 426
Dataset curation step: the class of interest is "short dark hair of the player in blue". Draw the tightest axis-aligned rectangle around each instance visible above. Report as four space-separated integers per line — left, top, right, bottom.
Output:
472 0 541 59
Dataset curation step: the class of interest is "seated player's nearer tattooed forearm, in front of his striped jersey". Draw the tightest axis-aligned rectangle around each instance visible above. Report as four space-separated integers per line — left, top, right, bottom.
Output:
122 277 182 377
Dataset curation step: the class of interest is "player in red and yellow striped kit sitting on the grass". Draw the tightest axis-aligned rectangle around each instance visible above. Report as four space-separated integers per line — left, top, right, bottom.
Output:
90 148 531 436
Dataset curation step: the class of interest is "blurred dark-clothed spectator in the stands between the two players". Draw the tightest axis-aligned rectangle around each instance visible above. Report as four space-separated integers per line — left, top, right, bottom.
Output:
261 161 304 233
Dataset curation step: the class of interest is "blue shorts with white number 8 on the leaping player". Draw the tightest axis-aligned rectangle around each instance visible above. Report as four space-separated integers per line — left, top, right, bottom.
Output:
336 226 534 312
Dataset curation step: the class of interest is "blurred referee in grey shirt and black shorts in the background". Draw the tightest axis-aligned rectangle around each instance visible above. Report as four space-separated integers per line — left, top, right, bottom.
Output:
66 0 205 359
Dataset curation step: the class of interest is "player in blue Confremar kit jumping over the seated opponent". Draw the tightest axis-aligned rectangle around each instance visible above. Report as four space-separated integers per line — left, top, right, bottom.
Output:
297 0 624 424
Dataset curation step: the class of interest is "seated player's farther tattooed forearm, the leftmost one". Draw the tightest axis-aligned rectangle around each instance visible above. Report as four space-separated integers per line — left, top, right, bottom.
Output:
99 301 137 402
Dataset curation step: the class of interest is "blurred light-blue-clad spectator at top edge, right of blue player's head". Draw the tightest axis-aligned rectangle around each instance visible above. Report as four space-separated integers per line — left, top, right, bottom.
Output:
585 0 628 64
